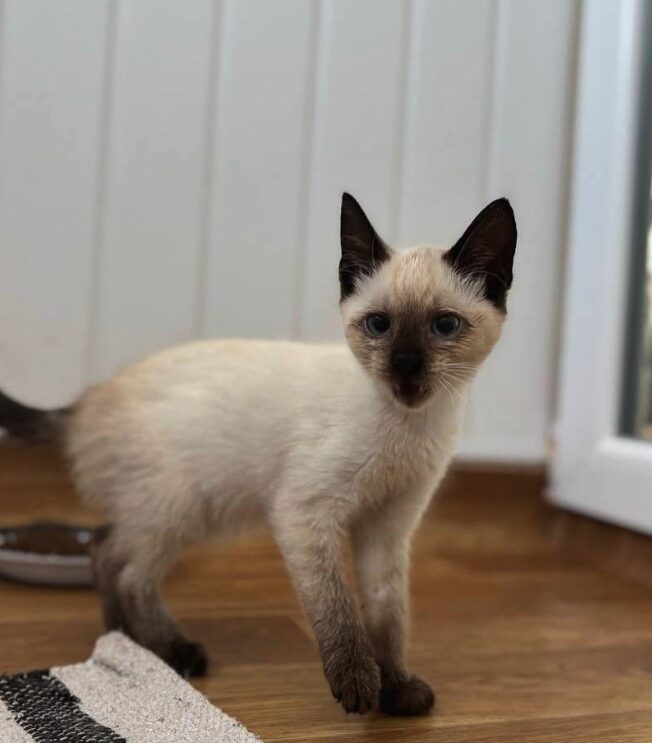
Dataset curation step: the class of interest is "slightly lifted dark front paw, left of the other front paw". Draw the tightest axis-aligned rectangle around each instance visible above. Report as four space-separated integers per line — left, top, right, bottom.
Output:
326 652 380 715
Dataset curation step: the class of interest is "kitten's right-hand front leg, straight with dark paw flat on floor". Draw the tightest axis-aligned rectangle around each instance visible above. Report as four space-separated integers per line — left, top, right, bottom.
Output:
353 501 435 715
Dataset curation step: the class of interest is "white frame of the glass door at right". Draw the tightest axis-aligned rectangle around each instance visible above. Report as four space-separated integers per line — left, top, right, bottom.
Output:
550 0 652 533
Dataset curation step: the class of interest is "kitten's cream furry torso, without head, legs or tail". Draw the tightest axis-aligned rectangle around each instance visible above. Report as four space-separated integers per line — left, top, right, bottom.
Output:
67 340 464 548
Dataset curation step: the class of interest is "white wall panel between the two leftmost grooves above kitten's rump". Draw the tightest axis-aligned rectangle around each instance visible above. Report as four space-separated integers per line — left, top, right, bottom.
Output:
93 0 213 377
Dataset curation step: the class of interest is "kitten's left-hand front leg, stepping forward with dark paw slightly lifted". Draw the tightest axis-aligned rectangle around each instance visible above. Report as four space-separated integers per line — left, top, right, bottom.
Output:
275 515 380 714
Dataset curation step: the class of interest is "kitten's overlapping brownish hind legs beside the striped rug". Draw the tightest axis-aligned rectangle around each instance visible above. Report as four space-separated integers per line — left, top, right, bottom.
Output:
95 526 208 677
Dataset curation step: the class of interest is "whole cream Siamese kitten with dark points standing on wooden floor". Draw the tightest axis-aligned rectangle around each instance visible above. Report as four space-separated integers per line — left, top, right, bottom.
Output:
0 194 516 715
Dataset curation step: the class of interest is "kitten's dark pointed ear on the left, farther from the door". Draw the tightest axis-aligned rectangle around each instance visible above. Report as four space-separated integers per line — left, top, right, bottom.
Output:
340 193 390 301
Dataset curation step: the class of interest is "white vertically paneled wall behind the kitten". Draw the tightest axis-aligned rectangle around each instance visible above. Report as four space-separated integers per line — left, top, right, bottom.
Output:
0 0 579 460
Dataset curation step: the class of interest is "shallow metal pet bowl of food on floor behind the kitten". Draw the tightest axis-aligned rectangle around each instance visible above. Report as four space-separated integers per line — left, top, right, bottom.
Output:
0 521 93 586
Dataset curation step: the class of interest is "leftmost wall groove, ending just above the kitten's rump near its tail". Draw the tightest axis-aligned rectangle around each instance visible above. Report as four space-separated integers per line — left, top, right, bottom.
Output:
86 0 121 381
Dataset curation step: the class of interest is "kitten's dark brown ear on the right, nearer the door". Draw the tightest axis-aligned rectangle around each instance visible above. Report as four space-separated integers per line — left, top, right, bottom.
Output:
444 199 516 311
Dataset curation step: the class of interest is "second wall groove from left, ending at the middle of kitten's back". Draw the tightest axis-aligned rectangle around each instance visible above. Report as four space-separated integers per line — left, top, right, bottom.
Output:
193 0 226 336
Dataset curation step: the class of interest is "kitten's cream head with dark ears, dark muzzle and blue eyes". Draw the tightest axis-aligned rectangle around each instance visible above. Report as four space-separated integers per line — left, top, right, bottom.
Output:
339 193 516 408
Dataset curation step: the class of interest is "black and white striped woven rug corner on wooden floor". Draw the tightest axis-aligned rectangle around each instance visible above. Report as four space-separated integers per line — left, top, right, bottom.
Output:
0 632 261 743
